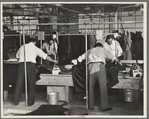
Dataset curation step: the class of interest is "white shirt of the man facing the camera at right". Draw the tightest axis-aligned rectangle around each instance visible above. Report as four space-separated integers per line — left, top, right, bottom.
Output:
104 40 123 57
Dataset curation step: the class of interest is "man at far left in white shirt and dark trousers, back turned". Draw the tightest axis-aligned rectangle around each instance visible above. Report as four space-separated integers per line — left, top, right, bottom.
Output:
12 38 57 106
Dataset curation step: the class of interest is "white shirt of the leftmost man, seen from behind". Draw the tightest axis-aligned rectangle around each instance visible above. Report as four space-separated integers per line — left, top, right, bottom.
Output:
16 42 47 63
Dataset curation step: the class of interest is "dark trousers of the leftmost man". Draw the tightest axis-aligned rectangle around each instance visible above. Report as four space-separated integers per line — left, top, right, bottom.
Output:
12 62 36 106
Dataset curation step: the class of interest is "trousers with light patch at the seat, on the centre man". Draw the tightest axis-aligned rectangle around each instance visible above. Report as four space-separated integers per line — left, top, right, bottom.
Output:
88 63 108 110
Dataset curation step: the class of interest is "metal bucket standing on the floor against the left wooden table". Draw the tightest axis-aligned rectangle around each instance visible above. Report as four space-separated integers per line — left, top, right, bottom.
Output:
48 92 59 105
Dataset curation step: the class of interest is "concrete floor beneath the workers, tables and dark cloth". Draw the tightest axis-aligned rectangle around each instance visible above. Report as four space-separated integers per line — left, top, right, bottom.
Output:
3 86 144 117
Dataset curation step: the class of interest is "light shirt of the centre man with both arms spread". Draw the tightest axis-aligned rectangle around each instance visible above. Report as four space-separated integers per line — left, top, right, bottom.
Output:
78 47 116 64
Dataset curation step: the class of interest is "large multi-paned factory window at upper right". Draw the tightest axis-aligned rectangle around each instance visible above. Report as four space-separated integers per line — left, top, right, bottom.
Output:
78 10 143 33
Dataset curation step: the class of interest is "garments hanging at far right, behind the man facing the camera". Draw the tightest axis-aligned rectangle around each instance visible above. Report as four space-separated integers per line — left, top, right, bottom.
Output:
118 31 143 60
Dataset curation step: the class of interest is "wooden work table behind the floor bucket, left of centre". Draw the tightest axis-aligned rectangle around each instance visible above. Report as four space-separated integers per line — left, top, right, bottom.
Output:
36 74 74 103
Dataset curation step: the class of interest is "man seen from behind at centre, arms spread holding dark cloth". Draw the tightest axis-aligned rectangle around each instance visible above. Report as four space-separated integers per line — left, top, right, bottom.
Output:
72 42 118 111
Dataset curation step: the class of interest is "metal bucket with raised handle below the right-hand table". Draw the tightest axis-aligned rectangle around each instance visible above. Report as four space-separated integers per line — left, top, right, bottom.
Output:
122 82 134 102
